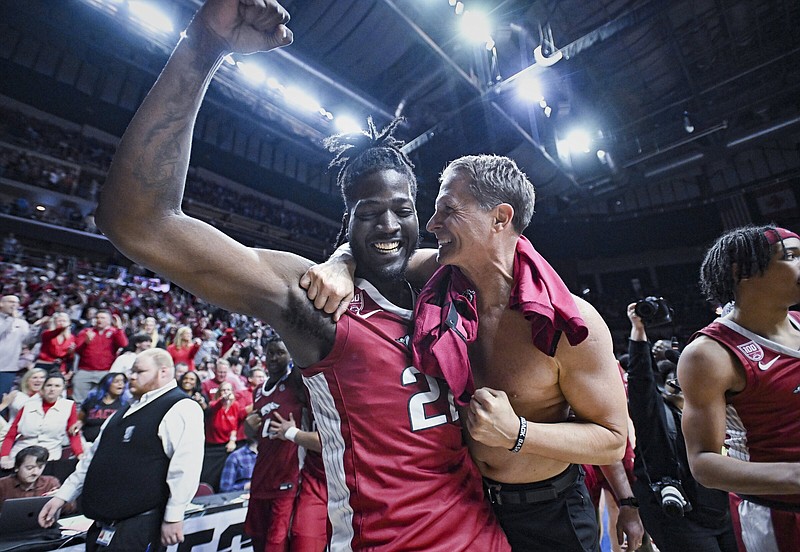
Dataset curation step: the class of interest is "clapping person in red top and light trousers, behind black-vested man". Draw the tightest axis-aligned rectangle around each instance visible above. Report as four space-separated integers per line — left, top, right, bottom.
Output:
72 310 128 403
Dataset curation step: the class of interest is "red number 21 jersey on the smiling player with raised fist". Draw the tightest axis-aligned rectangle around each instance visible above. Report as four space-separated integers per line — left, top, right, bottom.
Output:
303 280 510 552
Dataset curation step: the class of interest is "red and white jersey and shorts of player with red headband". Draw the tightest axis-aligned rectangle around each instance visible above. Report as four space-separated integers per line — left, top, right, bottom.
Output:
693 311 800 552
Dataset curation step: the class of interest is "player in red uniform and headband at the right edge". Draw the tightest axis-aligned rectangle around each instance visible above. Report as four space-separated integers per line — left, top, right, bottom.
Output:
678 226 800 552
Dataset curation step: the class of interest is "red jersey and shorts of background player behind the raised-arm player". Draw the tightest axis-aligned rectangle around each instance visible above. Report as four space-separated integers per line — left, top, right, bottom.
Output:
245 369 303 552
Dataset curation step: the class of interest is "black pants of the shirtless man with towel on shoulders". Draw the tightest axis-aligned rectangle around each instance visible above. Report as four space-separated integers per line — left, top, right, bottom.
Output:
484 468 600 552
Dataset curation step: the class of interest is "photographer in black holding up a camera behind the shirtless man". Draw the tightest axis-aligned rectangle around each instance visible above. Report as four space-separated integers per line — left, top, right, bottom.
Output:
628 297 737 552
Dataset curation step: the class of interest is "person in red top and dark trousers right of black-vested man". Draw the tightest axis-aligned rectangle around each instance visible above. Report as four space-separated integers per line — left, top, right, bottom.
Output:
199 382 247 489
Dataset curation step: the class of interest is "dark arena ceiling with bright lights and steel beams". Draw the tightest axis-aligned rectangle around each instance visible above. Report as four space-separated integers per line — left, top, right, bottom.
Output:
0 0 800 249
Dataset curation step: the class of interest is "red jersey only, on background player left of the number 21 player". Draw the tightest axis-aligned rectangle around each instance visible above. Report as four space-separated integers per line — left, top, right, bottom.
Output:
250 372 303 499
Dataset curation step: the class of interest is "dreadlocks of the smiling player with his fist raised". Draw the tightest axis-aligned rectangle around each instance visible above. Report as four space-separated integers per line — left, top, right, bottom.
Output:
323 117 417 247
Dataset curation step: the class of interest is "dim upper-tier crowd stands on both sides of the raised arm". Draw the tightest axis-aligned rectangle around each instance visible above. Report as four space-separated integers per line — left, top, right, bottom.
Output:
0 103 337 251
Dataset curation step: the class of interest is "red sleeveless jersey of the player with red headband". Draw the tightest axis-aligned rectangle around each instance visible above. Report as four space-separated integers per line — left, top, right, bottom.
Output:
692 311 800 504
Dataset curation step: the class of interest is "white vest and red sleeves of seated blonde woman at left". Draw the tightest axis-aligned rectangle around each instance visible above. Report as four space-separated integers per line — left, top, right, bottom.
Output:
0 394 83 460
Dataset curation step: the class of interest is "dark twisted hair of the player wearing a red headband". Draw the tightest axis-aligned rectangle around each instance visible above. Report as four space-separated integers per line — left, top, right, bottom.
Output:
700 226 783 305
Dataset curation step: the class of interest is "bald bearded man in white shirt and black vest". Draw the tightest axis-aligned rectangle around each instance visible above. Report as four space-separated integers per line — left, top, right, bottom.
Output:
39 349 204 551
